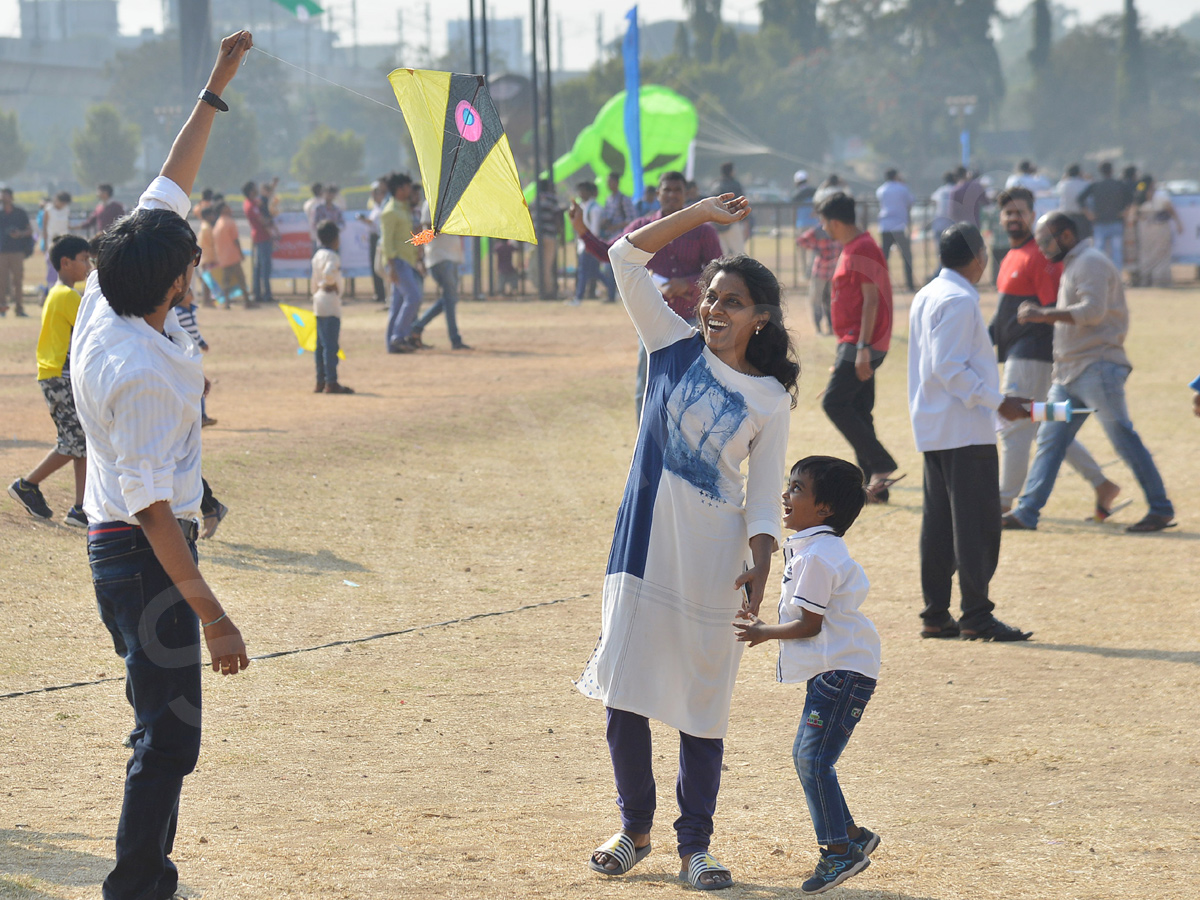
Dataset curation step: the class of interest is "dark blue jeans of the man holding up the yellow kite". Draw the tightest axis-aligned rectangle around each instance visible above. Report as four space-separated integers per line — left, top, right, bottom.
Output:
88 522 200 900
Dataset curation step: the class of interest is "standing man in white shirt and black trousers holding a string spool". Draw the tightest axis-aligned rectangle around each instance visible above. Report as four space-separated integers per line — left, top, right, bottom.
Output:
908 222 1032 641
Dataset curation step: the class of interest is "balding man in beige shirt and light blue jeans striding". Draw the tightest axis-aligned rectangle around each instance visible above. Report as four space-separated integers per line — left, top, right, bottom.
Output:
1003 212 1175 533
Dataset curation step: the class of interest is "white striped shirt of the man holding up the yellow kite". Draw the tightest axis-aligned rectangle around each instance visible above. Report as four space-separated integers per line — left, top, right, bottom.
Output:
71 175 204 524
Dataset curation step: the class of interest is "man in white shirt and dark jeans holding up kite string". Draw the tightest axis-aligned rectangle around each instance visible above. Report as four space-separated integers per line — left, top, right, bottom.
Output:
71 31 252 900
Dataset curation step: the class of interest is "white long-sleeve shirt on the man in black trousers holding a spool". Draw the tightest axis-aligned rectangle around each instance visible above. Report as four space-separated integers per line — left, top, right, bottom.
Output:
908 269 1004 452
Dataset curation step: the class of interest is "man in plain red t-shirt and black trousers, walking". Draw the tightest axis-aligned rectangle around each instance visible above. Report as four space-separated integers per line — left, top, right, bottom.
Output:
816 193 896 503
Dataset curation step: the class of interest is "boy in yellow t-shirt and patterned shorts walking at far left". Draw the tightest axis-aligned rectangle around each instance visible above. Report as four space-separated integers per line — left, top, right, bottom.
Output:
8 234 91 528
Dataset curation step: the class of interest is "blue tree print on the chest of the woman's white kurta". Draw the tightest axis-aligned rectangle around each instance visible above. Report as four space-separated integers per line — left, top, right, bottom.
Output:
662 356 746 500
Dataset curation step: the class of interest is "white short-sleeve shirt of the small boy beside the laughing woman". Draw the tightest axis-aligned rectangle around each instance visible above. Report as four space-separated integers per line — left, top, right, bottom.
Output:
775 526 880 682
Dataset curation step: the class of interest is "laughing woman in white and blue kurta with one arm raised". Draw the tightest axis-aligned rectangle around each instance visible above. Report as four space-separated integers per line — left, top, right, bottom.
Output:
578 194 799 890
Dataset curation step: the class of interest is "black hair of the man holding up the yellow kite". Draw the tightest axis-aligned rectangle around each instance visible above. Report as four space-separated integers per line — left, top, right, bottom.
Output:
96 209 196 318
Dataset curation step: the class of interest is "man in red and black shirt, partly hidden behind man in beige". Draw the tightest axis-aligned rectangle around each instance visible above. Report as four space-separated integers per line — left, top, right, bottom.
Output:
988 187 1121 520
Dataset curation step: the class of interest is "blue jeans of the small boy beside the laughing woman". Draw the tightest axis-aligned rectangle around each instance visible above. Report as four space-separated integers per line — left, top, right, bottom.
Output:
792 670 876 846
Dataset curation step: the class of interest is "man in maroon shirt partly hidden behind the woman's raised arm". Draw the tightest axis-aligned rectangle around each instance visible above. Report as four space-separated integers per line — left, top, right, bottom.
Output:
570 172 720 422
